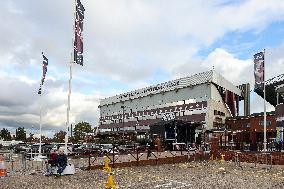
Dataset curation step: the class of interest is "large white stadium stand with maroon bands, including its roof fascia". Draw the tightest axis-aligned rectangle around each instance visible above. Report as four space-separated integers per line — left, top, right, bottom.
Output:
99 70 241 133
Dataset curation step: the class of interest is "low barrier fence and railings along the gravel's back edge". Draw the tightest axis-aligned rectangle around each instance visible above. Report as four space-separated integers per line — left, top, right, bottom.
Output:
0 148 274 173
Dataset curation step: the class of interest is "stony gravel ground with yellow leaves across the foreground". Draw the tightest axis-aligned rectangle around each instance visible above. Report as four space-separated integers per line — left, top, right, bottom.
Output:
0 161 284 189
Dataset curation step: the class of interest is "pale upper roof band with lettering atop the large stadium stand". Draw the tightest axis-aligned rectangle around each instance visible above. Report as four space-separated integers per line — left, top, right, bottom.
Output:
100 70 241 106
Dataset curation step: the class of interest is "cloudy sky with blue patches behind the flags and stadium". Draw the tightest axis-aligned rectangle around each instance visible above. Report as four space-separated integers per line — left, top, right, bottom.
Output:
0 0 284 136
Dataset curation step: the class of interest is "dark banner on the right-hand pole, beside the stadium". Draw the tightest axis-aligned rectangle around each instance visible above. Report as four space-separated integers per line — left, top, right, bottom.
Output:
254 52 264 90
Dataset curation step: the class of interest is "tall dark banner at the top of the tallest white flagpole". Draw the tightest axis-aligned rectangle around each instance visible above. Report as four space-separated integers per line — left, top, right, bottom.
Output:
74 0 85 66
